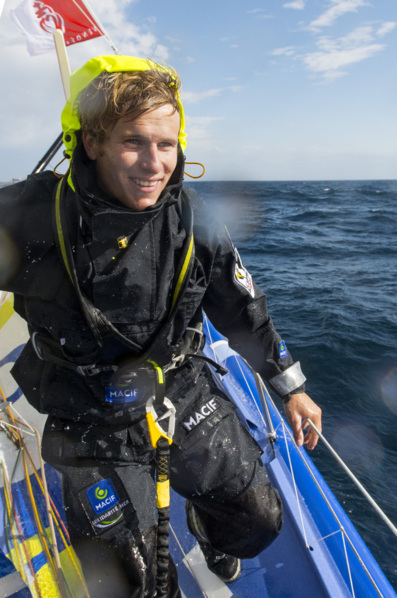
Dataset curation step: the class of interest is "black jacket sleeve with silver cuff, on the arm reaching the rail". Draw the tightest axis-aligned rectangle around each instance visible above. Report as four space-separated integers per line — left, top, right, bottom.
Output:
192 192 305 400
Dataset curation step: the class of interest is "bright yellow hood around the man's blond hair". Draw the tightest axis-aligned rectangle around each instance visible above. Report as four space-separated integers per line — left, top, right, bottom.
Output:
61 55 186 159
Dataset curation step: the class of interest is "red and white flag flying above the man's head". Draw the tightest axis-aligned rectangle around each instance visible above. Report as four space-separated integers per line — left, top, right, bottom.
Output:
11 0 104 56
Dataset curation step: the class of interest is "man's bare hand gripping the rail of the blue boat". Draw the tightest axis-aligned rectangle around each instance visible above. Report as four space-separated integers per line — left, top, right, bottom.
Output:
284 392 322 450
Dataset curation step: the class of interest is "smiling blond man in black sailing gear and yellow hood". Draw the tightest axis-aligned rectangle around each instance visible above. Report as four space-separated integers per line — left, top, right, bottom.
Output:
0 56 321 598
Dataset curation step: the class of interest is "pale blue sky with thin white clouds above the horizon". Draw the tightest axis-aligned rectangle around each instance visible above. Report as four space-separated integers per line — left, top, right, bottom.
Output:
0 0 397 181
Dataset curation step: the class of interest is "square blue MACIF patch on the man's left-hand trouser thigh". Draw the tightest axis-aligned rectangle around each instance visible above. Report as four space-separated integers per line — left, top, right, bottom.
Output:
79 475 135 534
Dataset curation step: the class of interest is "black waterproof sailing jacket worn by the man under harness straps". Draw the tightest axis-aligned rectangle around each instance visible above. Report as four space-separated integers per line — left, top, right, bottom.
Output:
0 150 302 425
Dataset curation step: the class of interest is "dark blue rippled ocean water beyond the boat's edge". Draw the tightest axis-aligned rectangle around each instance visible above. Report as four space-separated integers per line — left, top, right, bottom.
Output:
191 181 397 589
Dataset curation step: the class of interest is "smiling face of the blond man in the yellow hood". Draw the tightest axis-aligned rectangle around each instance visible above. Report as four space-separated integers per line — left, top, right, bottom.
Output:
83 104 180 212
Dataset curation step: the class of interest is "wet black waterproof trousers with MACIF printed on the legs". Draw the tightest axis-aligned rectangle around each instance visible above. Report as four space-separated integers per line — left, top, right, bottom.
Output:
43 368 282 598
